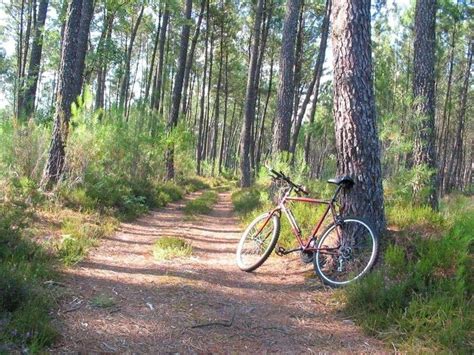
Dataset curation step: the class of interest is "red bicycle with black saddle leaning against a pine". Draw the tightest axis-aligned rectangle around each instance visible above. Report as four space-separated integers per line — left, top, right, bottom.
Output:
237 169 379 287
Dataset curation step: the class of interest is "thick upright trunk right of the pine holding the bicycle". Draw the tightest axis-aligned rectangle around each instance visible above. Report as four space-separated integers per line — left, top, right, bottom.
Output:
413 0 438 209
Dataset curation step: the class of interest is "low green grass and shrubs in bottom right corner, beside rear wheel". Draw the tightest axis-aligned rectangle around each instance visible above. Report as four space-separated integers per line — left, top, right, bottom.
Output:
343 203 474 353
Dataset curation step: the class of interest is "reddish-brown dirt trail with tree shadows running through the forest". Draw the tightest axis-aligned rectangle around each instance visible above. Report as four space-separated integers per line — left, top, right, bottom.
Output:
51 193 384 353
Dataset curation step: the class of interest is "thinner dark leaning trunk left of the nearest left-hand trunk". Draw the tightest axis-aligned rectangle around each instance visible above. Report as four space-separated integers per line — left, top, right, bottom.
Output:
19 0 48 118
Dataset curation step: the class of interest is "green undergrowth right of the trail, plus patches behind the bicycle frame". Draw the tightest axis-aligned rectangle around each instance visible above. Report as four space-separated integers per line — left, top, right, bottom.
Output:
232 174 474 353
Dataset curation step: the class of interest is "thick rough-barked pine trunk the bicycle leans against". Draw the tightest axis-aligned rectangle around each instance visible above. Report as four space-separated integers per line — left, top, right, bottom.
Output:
331 0 385 234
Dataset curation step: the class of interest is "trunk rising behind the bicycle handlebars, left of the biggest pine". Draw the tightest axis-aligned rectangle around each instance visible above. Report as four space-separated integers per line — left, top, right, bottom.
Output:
273 0 301 153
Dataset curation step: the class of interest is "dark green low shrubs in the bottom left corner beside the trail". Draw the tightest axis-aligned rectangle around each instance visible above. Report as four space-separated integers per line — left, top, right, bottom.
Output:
0 195 56 351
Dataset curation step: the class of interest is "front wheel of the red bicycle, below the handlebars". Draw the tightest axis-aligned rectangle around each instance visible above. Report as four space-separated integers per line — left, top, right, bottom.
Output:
237 213 280 272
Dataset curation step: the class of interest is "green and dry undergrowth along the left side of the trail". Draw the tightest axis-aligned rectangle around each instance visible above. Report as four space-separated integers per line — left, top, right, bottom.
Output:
0 116 223 352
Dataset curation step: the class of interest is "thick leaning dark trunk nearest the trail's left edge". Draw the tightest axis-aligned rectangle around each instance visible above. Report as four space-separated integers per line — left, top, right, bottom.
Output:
41 0 93 188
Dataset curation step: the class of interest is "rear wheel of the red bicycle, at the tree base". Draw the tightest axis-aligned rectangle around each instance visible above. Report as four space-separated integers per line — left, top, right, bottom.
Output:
313 218 379 287
